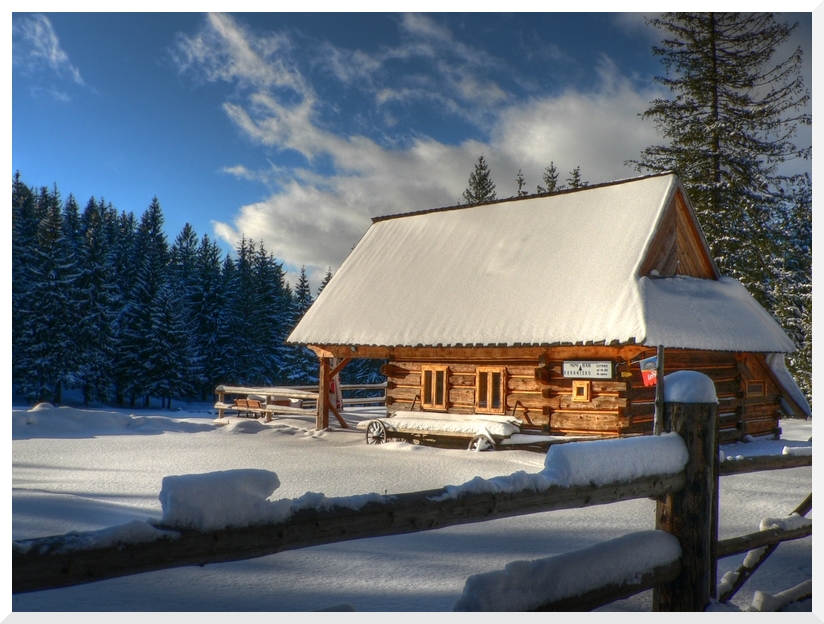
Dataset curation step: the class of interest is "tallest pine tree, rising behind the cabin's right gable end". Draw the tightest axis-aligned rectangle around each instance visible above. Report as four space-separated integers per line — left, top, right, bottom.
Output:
631 13 811 307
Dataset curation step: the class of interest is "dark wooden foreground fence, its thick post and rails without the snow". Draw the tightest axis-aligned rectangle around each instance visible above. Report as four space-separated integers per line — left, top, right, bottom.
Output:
12 394 812 611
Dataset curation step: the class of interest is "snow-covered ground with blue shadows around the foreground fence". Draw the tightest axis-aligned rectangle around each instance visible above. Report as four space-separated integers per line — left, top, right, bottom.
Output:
11 405 812 611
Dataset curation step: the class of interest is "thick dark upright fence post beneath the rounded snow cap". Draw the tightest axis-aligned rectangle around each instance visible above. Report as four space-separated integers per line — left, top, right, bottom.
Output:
652 402 718 611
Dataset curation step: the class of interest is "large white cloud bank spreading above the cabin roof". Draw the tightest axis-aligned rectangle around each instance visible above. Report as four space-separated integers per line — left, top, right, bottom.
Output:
181 16 668 283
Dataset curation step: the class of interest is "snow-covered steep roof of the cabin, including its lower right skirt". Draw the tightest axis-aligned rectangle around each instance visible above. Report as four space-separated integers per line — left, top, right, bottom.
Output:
289 174 794 352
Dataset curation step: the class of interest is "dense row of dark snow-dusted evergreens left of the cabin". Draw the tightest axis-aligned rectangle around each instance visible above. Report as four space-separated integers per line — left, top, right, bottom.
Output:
12 172 383 407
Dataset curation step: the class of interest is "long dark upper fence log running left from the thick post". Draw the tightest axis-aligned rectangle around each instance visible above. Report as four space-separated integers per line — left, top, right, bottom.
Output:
12 472 686 593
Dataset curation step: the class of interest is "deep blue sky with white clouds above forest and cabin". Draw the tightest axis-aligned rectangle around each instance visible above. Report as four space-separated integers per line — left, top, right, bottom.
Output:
12 13 812 290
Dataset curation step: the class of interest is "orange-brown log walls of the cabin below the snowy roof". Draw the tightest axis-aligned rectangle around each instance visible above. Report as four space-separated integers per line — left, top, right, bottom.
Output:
382 346 781 444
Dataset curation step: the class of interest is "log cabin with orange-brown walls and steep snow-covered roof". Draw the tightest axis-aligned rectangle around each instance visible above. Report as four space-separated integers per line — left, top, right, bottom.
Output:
288 173 810 442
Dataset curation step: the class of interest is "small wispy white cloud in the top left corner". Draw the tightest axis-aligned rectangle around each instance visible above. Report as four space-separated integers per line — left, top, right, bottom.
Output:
12 14 85 89
